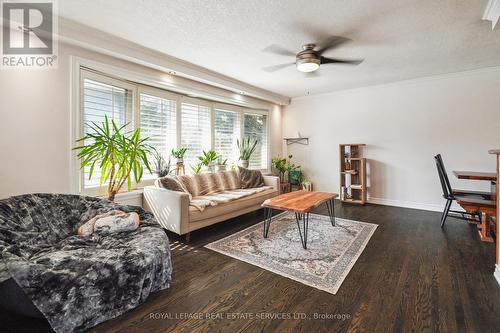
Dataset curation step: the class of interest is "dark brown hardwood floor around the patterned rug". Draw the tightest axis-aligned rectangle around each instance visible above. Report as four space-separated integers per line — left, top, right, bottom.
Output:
0 202 500 333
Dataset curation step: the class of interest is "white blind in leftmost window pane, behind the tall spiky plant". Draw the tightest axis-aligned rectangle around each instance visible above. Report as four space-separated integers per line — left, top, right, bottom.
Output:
83 79 132 188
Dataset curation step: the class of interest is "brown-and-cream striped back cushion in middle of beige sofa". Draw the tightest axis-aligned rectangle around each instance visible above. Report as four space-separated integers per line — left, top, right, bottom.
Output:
178 171 241 197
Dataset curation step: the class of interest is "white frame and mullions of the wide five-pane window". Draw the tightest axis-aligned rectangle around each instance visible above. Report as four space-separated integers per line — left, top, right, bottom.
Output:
70 68 272 196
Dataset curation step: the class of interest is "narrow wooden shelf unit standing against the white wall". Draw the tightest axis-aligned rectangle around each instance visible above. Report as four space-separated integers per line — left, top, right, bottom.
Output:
339 143 366 205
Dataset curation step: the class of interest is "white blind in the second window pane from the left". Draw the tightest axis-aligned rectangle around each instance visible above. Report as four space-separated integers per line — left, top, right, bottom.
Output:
139 93 177 179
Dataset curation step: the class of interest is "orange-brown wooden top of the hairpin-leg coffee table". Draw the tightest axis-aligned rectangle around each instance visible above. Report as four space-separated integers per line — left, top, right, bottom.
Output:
262 191 339 213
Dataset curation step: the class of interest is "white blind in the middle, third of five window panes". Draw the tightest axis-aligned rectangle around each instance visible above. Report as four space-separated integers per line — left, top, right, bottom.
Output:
181 102 212 172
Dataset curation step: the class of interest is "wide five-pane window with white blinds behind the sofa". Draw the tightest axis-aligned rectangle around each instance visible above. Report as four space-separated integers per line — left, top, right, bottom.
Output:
75 68 269 195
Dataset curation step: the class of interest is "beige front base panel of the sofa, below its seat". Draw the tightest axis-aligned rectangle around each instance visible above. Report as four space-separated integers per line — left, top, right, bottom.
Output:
189 188 277 222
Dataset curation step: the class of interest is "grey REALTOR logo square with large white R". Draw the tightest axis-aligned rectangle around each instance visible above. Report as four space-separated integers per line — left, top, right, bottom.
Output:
1 0 57 68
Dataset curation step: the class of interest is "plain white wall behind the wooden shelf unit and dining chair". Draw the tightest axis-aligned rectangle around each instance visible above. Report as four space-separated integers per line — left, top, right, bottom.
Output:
283 68 500 210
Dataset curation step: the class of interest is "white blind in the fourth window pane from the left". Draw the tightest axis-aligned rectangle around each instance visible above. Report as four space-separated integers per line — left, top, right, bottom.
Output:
214 109 241 165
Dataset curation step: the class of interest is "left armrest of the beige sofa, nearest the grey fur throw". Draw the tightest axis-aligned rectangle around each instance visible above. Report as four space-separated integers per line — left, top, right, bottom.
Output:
144 186 189 235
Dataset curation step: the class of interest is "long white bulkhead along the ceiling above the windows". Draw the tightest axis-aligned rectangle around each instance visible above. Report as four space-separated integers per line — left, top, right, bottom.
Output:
59 18 290 105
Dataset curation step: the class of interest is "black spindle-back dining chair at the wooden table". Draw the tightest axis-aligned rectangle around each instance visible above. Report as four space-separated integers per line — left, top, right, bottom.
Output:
434 154 491 228
